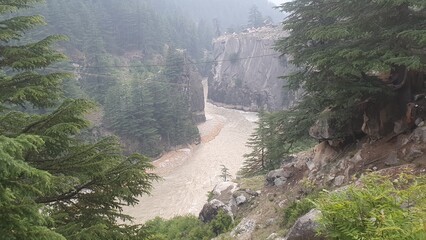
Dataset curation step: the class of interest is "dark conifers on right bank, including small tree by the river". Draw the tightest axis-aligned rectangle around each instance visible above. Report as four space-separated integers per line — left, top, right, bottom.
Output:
243 0 426 175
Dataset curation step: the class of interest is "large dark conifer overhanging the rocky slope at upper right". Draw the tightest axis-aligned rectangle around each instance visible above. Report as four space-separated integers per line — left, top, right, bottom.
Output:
276 0 426 140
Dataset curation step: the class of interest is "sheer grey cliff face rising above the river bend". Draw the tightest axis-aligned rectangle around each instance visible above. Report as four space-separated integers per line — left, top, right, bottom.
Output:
208 27 297 111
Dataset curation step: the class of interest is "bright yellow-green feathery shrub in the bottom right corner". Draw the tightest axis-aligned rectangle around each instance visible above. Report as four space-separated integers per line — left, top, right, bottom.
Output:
315 174 426 240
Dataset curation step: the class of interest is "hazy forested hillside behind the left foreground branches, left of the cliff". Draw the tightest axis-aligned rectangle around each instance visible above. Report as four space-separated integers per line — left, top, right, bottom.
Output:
18 0 278 156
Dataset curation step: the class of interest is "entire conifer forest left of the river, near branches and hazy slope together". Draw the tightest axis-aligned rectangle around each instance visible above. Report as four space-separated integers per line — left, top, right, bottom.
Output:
0 0 282 236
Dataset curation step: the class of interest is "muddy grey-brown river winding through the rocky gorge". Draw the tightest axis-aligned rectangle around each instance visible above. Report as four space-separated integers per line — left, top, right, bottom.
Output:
125 82 257 223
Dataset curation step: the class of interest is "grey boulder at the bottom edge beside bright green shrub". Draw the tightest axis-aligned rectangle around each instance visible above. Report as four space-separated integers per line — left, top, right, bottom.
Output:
284 209 325 240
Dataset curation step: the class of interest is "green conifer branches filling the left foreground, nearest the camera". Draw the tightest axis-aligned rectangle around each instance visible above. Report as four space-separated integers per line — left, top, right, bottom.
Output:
0 0 157 239
